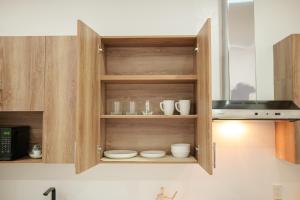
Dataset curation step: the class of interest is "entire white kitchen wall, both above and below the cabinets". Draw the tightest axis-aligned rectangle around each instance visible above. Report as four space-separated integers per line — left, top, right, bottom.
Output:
0 0 300 200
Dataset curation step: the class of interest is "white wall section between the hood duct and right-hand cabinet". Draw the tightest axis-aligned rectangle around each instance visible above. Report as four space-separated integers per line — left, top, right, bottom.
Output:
255 0 300 99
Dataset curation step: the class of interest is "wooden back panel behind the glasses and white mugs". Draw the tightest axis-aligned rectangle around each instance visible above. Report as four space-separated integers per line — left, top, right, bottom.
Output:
106 83 196 115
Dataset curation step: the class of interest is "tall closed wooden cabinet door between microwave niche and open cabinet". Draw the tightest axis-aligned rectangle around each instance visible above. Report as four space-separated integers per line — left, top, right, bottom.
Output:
43 36 77 163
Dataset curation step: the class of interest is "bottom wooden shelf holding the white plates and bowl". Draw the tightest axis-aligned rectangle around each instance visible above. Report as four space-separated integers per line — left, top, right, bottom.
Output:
101 155 197 164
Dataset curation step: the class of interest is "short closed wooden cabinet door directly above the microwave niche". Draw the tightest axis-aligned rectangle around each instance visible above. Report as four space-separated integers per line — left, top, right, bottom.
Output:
0 37 45 111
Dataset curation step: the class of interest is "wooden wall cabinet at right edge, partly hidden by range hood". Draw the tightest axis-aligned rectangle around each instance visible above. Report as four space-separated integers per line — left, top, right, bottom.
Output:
274 34 300 164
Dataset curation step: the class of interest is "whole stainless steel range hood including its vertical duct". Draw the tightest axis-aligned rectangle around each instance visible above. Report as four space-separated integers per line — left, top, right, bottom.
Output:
212 0 300 120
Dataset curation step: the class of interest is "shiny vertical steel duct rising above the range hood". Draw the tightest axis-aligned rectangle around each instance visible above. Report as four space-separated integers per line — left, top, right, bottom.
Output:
222 0 256 100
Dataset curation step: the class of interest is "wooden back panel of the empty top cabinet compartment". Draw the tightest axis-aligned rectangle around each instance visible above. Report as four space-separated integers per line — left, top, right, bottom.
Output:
106 46 194 75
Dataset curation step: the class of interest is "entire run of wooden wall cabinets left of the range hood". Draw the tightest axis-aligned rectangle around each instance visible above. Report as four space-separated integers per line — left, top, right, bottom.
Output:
0 20 213 174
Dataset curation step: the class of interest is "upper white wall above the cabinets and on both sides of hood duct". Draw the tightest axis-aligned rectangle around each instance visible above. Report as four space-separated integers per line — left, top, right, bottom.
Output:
0 0 300 99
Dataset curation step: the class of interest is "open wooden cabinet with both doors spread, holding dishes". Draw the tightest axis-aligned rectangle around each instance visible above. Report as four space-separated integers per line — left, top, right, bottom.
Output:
75 20 213 174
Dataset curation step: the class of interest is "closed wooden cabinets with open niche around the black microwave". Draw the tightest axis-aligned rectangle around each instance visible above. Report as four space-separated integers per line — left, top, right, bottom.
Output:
0 36 77 163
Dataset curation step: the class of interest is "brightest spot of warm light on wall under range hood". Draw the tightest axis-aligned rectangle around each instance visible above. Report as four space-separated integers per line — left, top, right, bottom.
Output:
219 121 245 138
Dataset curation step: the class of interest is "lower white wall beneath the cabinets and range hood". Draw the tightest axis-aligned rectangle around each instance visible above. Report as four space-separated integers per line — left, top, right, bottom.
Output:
0 122 300 200
